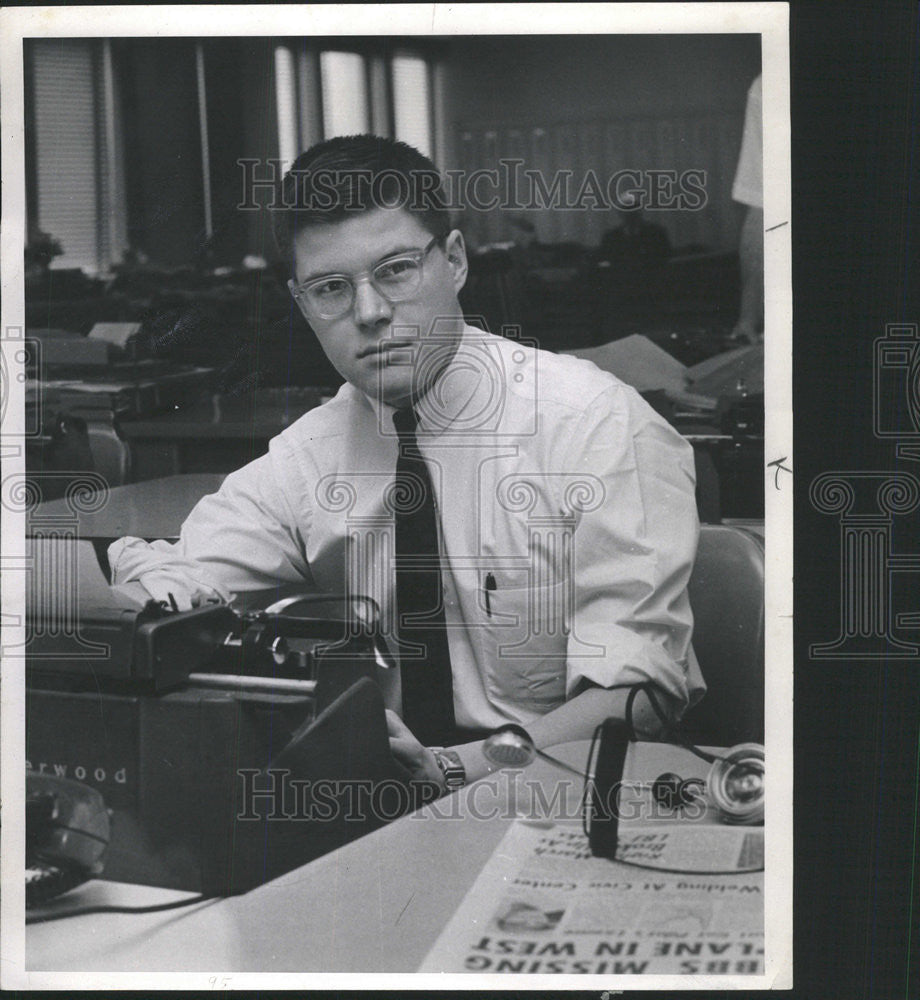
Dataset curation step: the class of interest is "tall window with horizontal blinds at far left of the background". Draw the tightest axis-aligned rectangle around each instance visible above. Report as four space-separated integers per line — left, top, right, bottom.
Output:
27 38 127 273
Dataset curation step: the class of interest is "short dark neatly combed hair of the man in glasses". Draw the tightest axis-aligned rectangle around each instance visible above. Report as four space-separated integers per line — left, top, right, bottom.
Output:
272 135 451 270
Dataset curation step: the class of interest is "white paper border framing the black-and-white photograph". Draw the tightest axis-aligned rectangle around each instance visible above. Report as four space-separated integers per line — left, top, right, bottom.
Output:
0 3 794 990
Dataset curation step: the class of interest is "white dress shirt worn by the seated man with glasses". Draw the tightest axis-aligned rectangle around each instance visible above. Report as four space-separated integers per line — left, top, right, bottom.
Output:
109 327 704 728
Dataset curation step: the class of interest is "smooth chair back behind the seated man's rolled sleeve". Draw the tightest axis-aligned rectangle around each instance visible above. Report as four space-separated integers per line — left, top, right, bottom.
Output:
681 524 764 746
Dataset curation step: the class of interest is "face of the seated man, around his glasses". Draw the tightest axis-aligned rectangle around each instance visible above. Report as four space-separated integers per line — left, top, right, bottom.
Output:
294 208 466 407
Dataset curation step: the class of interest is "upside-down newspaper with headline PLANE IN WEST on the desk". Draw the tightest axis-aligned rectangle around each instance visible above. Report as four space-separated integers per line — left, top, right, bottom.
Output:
419 821 764 976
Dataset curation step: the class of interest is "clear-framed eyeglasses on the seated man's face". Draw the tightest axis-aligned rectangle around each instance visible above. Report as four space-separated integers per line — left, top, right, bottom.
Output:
288 236 443 319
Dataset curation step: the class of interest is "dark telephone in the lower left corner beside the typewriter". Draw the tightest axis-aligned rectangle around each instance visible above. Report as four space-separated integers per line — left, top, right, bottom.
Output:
26 771 109 907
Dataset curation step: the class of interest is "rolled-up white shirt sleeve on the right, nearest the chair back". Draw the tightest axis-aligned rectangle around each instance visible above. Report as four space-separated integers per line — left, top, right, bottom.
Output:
566 384 705 707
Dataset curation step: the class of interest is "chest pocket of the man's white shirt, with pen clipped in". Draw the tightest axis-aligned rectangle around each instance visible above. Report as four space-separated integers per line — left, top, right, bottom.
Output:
477 583 568 715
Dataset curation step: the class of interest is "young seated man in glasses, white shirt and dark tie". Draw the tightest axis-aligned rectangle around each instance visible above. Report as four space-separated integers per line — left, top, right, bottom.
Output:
110 136 703 787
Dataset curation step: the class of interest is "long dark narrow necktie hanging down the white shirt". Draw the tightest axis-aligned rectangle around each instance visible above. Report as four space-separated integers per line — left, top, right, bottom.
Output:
393 410 455 746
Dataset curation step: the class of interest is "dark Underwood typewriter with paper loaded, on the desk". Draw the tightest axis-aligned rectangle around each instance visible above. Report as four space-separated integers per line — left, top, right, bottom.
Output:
24 536 420 896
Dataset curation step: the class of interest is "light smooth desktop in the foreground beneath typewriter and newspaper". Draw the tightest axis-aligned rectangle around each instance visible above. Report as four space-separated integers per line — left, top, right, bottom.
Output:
26 743 762 986
